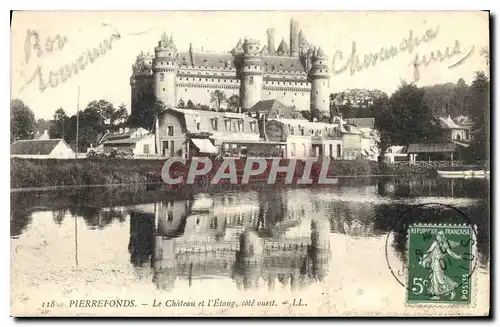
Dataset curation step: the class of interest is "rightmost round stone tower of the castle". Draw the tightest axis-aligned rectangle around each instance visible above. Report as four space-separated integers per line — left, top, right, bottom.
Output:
307 48 330 116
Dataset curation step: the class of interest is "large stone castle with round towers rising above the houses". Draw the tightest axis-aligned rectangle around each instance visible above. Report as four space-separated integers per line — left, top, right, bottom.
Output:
130 19 330 117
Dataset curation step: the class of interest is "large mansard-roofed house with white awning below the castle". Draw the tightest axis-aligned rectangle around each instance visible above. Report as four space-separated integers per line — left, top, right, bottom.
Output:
156 108 261 157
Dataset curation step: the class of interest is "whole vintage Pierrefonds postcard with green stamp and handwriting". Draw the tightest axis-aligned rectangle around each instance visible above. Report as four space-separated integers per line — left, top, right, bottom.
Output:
10 11 491 317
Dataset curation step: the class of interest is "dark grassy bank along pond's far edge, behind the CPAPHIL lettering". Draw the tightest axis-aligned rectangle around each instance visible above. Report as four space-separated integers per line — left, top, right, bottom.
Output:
10 158 430 192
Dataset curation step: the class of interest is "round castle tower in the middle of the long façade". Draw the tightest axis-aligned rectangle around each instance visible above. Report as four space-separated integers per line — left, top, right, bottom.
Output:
240 39 263 110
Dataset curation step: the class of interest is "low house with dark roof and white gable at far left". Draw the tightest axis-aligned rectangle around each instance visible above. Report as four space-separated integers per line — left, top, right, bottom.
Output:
10 139 75 159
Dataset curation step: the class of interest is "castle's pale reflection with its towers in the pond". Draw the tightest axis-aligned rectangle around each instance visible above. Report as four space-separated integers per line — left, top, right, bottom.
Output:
128 189 340 290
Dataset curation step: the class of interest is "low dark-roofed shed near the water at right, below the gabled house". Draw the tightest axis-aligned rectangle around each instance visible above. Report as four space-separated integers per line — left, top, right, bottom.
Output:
408 142 458 162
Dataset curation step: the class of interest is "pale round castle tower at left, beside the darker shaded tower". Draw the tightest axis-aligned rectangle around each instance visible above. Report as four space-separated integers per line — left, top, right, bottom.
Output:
153 33 177 108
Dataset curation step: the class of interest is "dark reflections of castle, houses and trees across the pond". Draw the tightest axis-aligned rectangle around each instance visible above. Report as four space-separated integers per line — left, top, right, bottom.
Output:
11 179 490 291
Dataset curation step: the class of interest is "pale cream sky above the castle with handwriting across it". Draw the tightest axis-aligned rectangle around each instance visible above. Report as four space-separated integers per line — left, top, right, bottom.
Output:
11 11 489 119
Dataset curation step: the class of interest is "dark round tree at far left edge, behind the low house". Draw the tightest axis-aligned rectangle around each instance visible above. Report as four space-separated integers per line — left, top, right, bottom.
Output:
10 99 36 142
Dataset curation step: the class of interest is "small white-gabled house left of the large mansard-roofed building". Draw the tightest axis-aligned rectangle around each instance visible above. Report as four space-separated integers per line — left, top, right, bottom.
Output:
102 134 156 158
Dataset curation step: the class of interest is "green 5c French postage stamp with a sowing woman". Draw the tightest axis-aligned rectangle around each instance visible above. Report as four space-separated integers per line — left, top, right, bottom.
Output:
406 225 476 305
